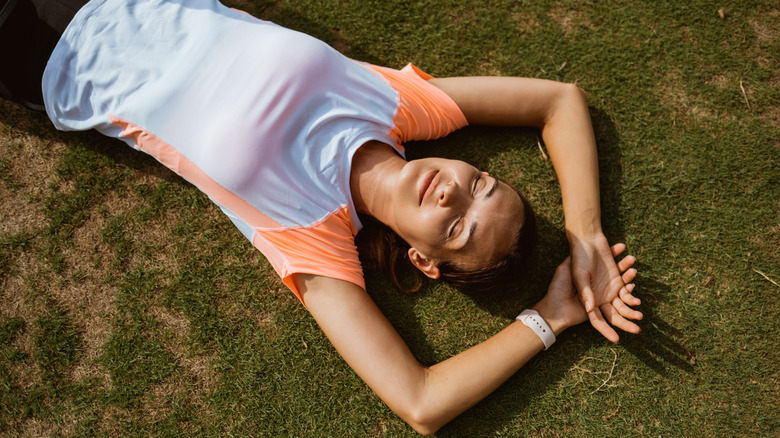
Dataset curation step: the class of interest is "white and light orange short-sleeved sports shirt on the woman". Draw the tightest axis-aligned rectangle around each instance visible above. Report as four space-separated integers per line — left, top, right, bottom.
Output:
42 0 466 298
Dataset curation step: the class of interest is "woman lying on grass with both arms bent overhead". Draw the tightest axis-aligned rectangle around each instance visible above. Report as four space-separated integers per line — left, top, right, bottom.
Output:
4 0 642 433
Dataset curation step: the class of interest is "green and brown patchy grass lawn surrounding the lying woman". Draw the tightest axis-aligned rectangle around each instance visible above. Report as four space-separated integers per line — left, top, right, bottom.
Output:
0 0 780 437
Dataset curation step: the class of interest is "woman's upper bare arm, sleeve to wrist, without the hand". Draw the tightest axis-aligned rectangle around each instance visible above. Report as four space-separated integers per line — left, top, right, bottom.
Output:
431 77 601 240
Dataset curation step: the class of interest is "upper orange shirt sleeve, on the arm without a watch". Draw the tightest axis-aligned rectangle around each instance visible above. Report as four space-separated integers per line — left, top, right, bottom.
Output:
363 64 468 143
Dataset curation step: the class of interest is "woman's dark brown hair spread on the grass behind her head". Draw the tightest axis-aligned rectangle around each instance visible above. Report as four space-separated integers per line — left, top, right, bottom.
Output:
356 184 537 293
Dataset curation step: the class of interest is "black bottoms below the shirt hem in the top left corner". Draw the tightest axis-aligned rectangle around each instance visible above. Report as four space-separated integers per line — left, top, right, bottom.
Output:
0 0 87 109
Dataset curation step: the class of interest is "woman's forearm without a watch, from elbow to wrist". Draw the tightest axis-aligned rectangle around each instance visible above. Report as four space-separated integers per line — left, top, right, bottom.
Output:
541 86 601 241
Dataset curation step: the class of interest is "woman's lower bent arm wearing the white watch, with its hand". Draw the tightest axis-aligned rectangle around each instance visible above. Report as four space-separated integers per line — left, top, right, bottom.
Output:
295 246 635 434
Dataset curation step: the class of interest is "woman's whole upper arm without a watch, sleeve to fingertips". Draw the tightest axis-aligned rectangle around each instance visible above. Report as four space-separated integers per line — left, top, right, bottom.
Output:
430 77 641 342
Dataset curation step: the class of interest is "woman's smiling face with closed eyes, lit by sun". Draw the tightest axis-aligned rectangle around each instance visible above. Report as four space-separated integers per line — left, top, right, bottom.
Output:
392 158 524 268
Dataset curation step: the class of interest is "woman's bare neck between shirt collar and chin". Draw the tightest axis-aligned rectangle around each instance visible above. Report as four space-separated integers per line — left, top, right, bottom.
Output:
349 141 406 227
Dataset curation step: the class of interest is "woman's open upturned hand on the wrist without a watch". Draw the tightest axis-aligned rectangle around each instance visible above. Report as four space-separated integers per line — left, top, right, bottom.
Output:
572 233 642 342
